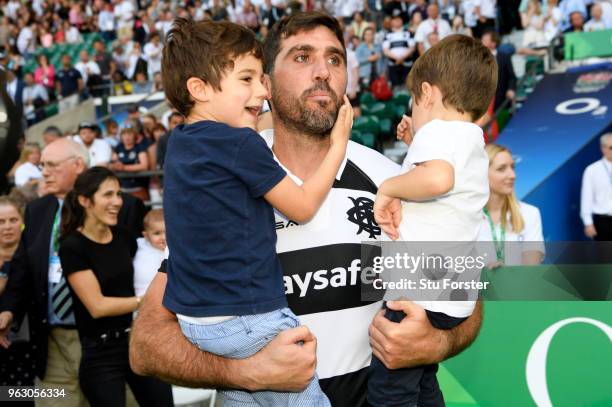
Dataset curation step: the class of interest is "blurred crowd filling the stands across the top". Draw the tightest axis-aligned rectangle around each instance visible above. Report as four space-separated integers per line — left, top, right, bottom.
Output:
0 0 612 124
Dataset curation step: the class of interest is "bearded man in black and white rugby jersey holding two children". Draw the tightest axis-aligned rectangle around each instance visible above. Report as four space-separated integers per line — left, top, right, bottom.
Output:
130 12 481 407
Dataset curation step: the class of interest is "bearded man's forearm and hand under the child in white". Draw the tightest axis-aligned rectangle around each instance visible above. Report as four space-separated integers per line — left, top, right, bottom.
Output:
370 301 483 369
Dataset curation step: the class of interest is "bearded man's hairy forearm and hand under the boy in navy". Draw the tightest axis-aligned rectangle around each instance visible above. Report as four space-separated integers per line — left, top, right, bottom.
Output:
130 273 316 391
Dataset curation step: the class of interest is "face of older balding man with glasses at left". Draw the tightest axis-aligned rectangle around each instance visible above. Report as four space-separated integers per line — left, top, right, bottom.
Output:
41 140 84 196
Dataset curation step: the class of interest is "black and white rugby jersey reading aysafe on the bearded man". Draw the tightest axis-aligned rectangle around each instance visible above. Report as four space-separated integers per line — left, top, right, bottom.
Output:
261 130 400 407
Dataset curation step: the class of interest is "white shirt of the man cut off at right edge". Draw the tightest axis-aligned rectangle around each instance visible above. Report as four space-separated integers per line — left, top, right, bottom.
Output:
580 158 612 226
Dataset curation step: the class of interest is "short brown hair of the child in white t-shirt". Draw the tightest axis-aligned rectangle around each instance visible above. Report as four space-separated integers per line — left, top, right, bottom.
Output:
408 34 497 120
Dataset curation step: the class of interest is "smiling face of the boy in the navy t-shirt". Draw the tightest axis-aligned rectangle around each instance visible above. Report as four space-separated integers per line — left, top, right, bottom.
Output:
208 55 268 130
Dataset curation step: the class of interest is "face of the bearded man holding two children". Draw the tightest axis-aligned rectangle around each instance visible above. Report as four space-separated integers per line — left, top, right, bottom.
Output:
271 27 347 137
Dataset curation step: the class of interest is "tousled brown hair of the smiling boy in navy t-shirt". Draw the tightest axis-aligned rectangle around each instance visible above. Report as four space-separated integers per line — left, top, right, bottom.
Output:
162 18 262 116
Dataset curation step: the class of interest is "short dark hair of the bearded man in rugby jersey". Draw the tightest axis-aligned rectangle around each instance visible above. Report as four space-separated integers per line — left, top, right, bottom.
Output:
263 11 346 75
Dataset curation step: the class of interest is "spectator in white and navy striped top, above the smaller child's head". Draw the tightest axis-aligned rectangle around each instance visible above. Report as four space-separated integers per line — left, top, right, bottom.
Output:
382 15 416 88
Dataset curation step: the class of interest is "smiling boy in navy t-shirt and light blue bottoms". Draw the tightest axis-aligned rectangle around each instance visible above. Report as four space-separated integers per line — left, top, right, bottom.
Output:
162 18 353 406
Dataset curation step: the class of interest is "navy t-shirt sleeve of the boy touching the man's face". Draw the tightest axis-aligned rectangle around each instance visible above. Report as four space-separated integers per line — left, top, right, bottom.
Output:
233 131 287 198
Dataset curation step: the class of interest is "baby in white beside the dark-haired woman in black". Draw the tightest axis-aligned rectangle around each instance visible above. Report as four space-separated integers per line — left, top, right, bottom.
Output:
134 209 166 297
